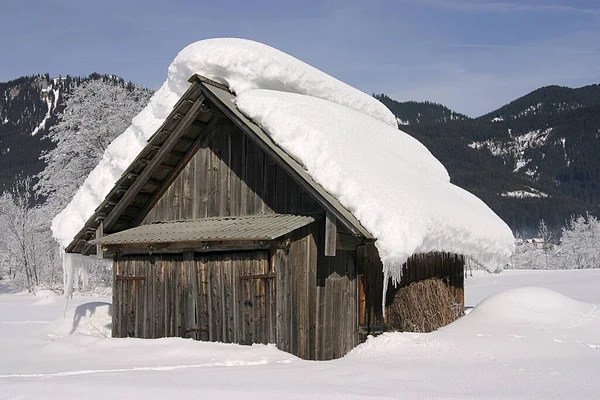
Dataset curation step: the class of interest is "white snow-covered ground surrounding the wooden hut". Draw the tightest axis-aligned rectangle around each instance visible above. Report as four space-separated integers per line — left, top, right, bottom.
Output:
0 270 600 399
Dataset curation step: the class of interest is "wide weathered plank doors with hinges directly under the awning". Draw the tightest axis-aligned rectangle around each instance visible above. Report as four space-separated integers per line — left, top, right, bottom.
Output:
113 250 275 344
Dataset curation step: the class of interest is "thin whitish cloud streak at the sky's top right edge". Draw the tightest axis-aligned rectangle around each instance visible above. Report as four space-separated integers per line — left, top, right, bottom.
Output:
397 0 600 15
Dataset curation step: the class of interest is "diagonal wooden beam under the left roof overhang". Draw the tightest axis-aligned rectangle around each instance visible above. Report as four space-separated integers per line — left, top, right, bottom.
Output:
104 95 205 230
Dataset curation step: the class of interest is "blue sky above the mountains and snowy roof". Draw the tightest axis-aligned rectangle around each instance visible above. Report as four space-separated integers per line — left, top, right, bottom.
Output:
0 0 600 116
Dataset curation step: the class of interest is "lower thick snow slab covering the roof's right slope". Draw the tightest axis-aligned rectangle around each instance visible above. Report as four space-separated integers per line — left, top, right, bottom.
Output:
236 90 514 279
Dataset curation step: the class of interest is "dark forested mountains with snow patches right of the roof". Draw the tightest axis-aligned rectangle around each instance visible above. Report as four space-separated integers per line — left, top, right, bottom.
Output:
375 85 600 234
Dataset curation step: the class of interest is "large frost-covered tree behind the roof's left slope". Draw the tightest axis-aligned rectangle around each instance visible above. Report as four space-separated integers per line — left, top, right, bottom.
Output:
36 79 152 212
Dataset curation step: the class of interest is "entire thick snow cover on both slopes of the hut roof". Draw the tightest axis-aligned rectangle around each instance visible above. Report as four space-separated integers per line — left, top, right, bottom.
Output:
52 39 514 279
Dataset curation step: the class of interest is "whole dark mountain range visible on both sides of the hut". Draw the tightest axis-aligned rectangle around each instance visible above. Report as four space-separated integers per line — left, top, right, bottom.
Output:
0 74 600 234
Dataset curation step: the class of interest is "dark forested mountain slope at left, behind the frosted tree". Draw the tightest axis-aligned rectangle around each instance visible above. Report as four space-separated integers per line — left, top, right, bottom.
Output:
0 73 149 193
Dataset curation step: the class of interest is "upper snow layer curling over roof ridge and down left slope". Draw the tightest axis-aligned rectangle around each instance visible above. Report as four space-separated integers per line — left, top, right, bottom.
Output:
52 39 396 247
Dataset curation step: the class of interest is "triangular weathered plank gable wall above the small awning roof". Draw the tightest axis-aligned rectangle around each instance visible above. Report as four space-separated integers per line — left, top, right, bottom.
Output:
143 119 320 223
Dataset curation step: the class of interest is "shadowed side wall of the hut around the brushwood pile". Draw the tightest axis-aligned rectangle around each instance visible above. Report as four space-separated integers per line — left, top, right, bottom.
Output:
357 244 464 332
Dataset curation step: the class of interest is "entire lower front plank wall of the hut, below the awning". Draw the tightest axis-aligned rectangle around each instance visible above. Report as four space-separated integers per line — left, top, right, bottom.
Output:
113 218 359 360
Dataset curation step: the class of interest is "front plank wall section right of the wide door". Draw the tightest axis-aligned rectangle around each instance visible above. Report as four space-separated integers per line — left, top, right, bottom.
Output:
273 220 359 360
